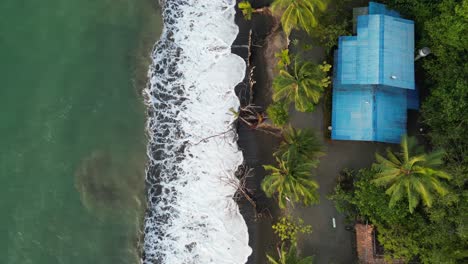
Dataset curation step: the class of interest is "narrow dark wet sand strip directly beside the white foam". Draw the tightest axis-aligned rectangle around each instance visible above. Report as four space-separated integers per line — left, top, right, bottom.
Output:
231 2 279 264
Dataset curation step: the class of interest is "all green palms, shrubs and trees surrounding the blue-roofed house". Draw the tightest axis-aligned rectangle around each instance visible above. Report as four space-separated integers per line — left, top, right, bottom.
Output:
236 0 468 264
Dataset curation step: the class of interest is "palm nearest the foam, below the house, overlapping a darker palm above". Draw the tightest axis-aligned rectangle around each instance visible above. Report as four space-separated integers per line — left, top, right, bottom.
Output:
261 155 318 208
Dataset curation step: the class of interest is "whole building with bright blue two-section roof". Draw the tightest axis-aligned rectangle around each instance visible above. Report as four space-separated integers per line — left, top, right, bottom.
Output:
331 2 418 143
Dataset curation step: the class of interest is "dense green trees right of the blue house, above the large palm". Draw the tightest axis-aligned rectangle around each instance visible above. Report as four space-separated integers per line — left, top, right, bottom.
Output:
385 0 468 166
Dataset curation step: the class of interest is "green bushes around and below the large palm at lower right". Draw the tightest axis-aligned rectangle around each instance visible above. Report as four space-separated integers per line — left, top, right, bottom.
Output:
329 169 468 263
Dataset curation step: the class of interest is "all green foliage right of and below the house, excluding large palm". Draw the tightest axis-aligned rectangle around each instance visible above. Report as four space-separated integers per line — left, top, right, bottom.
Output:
331 0 468 264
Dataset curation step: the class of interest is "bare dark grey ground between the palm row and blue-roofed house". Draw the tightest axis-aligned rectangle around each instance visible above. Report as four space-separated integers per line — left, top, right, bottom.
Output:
292 102 386 264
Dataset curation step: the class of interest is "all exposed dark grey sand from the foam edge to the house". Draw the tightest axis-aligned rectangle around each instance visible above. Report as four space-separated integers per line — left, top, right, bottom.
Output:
233 0 420 264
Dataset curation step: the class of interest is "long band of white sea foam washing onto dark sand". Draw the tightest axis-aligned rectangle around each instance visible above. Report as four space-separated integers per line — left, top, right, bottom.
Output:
142 0 252 264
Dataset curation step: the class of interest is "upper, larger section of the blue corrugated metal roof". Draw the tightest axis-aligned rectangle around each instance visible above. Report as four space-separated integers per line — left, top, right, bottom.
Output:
335 15 414 89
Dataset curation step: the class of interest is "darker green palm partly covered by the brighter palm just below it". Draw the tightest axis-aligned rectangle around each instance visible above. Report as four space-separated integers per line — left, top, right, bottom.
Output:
274 126 325 163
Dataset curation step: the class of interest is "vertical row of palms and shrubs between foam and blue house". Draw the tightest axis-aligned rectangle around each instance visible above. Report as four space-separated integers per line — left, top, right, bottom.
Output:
233 0 331 264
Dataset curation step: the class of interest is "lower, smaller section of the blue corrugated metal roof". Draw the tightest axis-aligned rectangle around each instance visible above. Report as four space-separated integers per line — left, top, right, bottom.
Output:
332 85 407 143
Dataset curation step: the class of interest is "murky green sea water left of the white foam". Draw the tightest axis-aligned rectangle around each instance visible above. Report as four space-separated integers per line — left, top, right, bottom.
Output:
0 0 160 264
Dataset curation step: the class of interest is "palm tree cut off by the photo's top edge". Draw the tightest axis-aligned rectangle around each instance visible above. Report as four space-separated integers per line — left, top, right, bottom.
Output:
271 0 327 36
